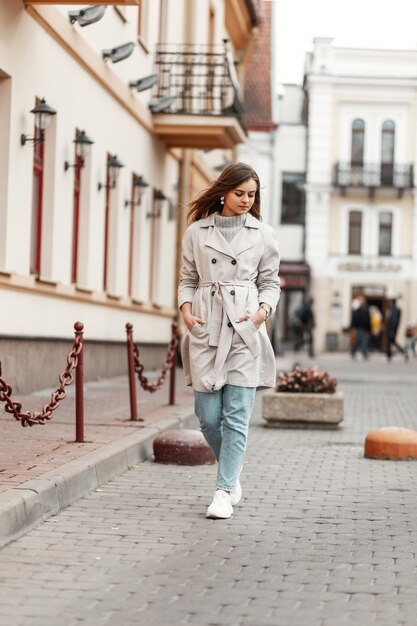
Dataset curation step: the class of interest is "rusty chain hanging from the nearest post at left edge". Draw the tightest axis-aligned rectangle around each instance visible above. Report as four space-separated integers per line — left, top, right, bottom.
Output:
0 322 84 426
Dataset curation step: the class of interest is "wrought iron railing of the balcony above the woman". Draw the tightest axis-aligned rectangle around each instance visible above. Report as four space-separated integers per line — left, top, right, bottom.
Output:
149 42 243 118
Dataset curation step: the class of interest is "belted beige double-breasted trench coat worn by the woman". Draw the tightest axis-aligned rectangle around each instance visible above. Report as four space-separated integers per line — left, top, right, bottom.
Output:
178 213 280 392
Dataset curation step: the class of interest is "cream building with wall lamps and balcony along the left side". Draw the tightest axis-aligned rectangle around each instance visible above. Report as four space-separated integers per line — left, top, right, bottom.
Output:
0 0 260 390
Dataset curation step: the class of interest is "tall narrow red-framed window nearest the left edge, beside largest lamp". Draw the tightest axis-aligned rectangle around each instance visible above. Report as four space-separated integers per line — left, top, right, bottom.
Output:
30 98 45 275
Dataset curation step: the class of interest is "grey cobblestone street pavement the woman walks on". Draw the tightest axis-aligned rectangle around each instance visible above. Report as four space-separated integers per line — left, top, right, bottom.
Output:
0 355 417 626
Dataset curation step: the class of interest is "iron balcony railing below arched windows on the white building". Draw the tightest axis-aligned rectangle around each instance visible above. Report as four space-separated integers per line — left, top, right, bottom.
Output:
335 162 414 189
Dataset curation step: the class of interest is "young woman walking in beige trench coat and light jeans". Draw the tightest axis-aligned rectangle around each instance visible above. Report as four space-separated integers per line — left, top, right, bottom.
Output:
178 163 280 519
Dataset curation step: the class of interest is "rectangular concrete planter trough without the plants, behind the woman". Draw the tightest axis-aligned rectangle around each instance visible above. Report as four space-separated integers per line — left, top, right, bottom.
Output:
262 391 344 428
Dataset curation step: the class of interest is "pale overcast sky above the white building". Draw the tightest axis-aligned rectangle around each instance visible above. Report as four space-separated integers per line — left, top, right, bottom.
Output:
271 0 417 83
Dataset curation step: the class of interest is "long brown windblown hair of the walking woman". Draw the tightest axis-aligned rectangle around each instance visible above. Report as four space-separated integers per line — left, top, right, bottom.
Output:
187 163 261 224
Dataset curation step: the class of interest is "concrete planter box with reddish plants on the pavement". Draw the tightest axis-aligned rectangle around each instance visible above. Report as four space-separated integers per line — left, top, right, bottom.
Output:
262 366 344 428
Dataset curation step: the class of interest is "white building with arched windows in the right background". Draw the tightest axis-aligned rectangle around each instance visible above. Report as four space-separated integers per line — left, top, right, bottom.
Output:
277 38 417 350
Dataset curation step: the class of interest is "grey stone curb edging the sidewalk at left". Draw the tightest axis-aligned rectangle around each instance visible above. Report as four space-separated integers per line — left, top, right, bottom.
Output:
0 407 196 548
